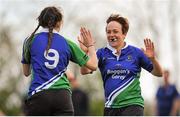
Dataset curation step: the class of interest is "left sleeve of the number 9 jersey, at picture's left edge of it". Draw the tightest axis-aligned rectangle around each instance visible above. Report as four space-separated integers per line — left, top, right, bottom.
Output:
21 38 30 64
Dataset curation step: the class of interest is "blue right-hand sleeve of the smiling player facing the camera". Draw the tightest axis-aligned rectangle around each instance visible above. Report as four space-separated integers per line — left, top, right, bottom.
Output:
137 49 153 72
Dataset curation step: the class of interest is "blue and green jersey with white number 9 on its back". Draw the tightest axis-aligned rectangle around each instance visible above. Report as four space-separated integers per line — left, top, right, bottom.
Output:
22 29 89 96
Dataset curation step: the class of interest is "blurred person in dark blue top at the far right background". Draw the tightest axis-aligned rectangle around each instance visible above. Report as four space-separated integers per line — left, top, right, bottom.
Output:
156 70 179 116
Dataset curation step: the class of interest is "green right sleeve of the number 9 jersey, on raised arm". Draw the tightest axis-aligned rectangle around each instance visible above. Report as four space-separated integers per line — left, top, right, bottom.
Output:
66 39 89 66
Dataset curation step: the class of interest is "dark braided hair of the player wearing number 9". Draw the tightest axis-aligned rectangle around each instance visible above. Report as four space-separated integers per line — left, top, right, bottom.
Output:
29 6 63 54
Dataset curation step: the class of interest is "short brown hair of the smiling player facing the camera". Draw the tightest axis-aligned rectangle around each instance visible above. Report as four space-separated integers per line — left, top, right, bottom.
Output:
106 14 129 34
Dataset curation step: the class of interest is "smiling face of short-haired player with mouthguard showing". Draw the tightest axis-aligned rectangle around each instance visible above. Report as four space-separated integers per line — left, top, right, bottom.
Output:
106 21 125 49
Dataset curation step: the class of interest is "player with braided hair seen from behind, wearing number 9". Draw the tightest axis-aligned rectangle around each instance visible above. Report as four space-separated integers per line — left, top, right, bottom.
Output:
21 6 97 116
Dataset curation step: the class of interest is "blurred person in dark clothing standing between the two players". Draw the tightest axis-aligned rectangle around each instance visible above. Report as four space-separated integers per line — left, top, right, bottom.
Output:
66 70 89 116
